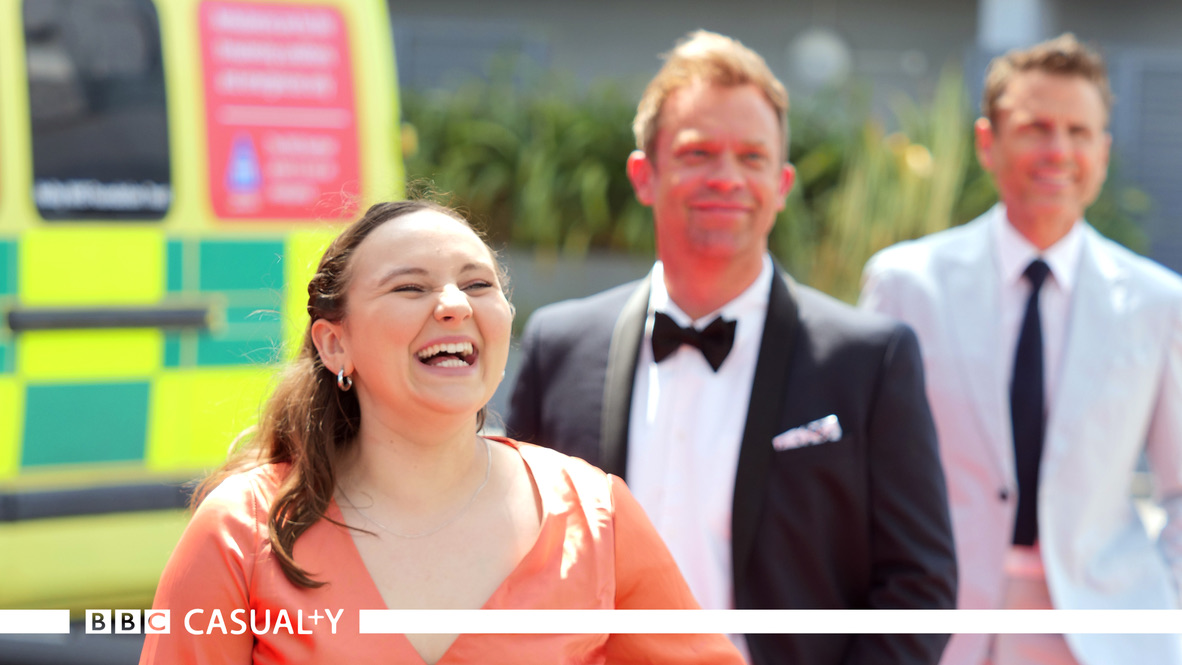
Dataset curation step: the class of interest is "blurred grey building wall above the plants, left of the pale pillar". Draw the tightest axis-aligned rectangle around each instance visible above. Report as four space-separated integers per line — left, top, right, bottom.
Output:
391 0 975 100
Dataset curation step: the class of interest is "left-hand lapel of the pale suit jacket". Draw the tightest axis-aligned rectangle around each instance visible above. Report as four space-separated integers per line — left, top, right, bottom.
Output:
941 207 1015 481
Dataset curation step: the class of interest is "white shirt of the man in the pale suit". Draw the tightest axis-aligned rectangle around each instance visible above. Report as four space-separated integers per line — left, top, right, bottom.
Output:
989 206 1084 578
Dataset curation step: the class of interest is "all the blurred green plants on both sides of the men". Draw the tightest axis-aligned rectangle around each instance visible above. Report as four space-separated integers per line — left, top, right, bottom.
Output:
403 61 1150 301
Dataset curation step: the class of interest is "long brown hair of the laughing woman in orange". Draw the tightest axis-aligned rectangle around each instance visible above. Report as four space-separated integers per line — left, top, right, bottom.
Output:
190 201 494 588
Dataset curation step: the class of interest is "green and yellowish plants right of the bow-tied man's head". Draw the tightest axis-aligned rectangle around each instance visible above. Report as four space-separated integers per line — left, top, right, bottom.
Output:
771 66 1148 302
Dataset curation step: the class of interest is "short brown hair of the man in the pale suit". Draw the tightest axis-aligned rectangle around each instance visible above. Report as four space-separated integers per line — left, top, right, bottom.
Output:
981 32 1113 124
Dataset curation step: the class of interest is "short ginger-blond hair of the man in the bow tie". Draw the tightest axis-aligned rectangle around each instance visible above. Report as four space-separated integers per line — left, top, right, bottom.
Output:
632 30 788 159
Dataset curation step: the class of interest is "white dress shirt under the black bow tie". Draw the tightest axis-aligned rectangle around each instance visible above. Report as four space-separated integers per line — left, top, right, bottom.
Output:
626 255 774 609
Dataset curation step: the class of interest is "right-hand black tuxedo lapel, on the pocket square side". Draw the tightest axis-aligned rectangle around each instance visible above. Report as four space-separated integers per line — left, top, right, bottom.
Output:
730 266 799 589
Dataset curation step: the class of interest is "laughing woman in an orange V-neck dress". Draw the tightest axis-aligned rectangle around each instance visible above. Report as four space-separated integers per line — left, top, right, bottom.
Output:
141 202 742 665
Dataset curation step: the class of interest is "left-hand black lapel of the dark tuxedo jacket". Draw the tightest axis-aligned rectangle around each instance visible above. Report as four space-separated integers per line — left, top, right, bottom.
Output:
599 274 652 477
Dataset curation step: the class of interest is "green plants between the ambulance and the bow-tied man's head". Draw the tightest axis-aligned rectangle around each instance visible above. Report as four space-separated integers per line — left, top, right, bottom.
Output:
402 63 652 255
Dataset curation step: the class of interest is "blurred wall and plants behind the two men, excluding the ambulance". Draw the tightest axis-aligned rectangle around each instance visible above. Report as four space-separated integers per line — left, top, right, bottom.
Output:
391 0 1182 420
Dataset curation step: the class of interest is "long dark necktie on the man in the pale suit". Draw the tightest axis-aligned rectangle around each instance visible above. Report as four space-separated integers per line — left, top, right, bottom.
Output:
1009 259 1051 546
